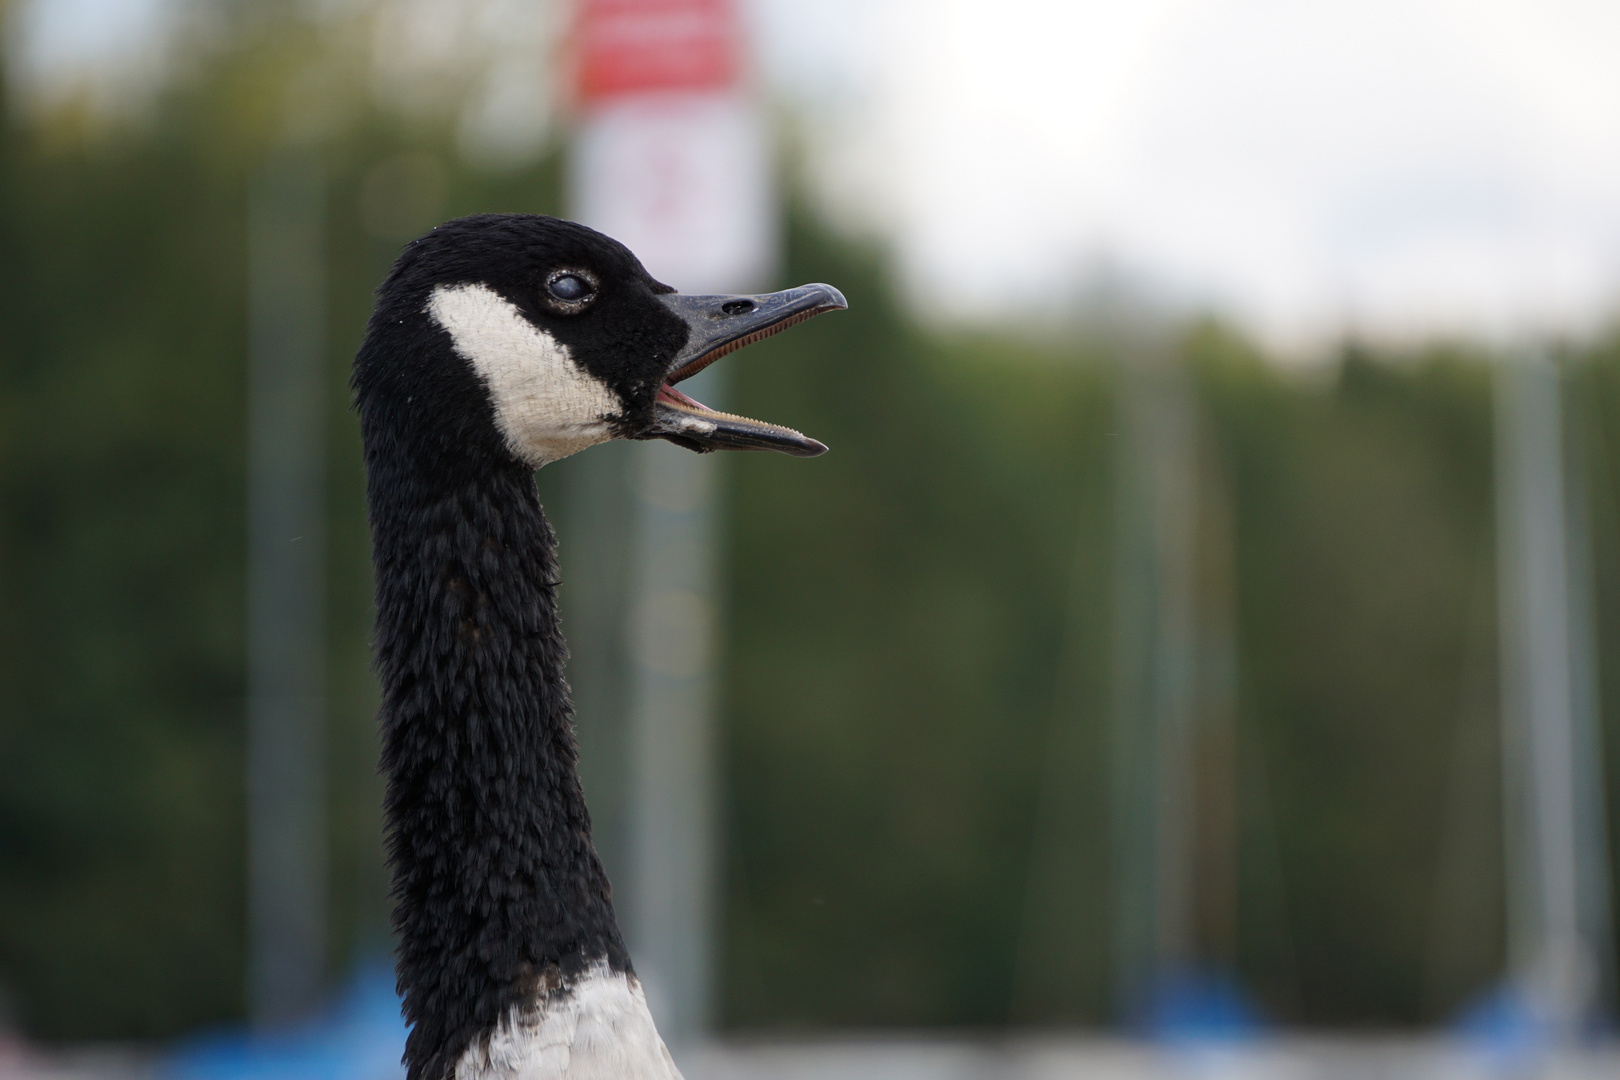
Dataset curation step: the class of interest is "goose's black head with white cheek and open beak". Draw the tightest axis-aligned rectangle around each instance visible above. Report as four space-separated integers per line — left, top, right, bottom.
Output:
355 214 846 468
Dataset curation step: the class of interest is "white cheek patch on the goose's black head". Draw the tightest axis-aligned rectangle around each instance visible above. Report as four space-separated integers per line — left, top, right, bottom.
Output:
428 285 624 468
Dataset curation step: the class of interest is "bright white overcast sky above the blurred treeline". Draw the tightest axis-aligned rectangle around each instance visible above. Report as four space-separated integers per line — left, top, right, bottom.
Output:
24 0 1620 343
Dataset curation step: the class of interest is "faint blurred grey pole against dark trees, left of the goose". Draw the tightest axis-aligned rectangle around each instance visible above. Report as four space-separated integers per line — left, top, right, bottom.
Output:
248 152 326 1025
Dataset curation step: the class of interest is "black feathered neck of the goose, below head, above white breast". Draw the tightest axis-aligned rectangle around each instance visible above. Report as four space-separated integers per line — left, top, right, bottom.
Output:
368 447 629 1080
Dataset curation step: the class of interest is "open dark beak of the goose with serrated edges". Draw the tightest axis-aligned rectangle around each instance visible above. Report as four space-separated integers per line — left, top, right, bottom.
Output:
638 285 849 458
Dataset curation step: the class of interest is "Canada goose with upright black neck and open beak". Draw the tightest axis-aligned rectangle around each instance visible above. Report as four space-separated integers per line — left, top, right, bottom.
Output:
352 214 846 1080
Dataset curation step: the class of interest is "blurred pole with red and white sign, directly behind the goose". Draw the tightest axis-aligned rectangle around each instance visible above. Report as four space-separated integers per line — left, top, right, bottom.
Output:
570 0 774 1044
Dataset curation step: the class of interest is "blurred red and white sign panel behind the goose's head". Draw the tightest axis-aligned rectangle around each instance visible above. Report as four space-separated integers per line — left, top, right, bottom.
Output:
570 0 774 293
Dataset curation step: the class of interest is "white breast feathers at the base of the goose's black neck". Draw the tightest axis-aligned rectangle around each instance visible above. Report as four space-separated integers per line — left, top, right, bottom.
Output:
455 960 680 1080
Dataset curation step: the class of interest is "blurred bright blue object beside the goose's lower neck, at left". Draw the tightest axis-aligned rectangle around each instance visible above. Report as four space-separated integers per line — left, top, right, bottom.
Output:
157 962 405 1080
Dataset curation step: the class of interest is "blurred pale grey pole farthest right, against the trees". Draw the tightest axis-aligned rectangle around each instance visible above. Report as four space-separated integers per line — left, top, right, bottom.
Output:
1495 350 1610 1041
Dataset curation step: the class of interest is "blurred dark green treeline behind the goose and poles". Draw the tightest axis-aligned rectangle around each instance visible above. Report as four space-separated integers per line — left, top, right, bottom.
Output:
0 2 1620 1038
